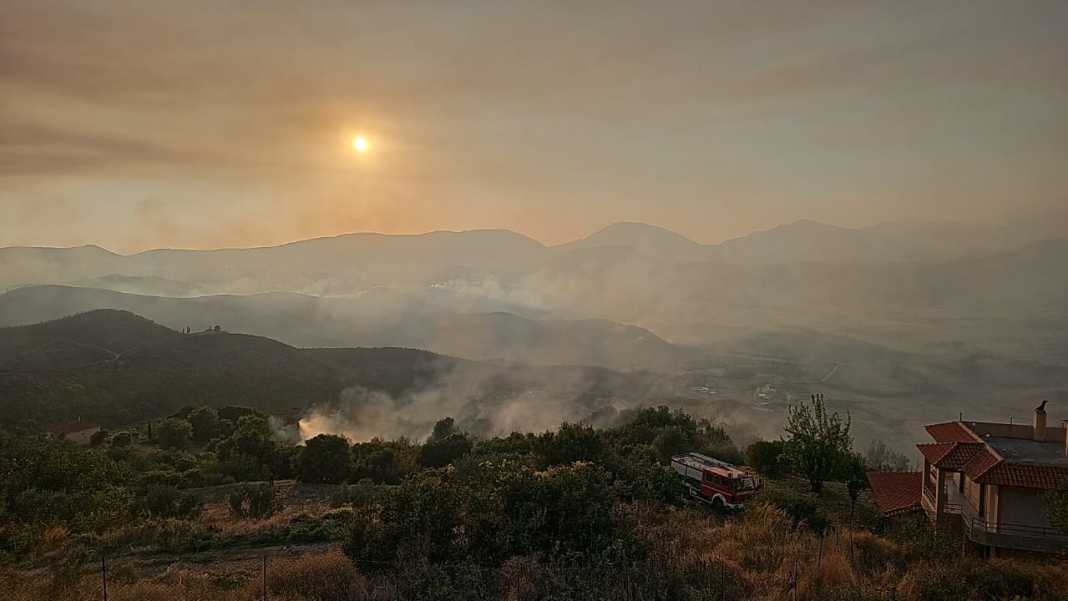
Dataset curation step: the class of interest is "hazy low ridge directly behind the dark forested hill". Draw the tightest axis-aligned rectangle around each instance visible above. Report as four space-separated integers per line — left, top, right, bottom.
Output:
0 286 689 369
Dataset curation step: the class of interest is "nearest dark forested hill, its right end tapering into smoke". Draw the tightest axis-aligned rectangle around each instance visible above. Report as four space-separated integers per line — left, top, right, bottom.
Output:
0 310 683 433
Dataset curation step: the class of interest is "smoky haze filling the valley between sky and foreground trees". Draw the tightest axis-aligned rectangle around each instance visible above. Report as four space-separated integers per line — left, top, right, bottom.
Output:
0 212 1068 445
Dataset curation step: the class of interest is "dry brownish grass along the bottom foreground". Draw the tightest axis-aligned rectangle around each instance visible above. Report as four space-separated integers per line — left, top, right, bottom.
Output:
0 506 1068 601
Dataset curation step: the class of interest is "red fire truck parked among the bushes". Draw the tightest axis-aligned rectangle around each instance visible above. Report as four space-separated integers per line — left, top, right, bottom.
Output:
671 453 760 509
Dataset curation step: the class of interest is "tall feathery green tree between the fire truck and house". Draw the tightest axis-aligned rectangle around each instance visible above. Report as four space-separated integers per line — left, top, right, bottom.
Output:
783 395 853 494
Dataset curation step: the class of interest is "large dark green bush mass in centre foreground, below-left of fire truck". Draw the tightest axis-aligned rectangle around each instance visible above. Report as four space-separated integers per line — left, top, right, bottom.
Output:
345 463 627 571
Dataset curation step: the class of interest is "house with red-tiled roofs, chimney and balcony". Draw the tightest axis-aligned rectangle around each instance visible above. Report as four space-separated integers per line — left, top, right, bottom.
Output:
868 401 1068 555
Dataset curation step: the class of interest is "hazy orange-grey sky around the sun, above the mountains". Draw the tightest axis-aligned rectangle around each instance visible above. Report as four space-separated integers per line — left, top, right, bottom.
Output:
0 0 1068 251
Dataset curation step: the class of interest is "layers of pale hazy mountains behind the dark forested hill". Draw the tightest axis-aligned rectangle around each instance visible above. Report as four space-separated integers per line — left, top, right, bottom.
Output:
0 213 1068 369
